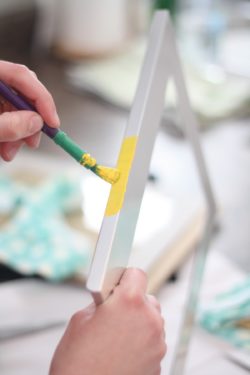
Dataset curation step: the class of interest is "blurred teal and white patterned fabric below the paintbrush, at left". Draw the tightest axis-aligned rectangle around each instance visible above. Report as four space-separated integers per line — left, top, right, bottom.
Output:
0 176 90 280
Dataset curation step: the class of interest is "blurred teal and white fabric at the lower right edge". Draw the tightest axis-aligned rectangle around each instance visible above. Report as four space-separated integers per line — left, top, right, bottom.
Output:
200 277 250 354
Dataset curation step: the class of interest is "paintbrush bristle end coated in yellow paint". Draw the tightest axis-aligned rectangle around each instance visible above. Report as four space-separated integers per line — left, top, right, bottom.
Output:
80 153 120 184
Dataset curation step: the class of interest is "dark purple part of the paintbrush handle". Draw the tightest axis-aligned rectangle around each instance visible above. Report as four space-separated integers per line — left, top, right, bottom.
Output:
0 81 58 139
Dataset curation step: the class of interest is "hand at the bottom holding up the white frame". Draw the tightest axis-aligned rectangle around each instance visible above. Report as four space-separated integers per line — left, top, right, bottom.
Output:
50 269 166 375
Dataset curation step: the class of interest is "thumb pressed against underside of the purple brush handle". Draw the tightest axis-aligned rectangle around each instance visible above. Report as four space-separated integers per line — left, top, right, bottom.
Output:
0 111 43 142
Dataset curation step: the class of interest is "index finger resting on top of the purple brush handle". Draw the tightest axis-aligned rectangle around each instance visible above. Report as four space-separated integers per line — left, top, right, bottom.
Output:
0 61 60 127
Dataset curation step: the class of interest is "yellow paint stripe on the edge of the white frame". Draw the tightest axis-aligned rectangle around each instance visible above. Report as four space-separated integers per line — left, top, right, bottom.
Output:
105 136 137 216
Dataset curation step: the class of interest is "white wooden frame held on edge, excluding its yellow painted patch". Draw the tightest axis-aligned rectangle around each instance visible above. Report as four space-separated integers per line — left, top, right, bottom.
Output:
87 11 216 375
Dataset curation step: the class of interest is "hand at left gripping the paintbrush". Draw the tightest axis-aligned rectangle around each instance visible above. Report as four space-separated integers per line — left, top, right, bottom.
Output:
0 61 59 161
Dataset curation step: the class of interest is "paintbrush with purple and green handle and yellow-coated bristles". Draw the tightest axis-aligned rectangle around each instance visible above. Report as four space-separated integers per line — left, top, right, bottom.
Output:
0 81 120 184
